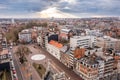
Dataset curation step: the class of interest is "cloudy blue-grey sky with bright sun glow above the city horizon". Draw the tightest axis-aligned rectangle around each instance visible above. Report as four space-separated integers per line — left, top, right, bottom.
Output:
0 0 120 18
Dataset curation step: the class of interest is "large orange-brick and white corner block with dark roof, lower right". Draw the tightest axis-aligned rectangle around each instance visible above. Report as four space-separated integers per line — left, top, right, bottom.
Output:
76 52 115 80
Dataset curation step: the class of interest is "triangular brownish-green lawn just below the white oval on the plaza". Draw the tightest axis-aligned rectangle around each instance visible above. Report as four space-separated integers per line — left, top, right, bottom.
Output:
32 63 46 78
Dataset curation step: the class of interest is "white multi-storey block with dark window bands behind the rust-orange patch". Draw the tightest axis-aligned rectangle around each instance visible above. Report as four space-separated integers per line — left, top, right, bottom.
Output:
70 36 96 50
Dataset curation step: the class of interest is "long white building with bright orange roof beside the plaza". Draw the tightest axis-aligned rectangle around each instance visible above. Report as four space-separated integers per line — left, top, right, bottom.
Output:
46 40 63 60
